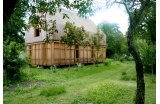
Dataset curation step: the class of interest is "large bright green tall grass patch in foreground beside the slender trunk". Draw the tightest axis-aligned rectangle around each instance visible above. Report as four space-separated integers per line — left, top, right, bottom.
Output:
72 82 133 104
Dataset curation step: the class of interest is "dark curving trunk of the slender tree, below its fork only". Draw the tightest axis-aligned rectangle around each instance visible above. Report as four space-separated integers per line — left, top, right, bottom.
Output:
127 23 145 104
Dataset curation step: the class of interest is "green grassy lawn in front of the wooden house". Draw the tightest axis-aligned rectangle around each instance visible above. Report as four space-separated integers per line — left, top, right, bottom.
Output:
3 60 156 104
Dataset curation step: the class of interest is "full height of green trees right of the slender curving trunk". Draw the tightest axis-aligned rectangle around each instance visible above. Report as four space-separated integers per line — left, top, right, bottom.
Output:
134 2 156 74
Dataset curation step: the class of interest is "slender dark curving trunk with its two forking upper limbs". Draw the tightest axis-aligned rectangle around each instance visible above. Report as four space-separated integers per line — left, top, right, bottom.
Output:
116 0 149 104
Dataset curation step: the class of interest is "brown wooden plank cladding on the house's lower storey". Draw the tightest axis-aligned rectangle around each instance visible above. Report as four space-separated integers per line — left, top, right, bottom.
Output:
26 42 106 66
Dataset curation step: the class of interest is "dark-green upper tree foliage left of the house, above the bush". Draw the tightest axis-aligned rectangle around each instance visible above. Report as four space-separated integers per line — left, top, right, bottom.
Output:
3 0 28 43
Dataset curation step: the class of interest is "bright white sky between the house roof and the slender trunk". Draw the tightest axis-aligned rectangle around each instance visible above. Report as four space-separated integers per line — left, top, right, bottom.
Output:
90 4 129 34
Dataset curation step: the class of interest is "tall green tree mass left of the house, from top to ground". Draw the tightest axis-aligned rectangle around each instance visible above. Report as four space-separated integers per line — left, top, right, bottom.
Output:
3 1 27 85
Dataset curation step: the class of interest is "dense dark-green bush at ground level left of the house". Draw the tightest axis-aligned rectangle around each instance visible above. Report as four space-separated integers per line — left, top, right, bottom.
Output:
3 42 25 85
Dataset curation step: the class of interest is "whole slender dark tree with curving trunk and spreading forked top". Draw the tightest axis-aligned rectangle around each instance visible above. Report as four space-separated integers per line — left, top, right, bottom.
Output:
105 0 155 104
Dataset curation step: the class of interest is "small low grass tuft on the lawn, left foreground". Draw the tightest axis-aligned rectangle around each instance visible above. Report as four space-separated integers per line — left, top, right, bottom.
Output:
40 86 66 97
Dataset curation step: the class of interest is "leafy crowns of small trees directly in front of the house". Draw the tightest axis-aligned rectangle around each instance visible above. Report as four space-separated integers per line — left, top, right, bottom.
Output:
60 22 104 63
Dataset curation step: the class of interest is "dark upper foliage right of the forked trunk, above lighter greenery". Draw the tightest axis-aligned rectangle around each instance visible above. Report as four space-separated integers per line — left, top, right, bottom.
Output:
135 0 156 44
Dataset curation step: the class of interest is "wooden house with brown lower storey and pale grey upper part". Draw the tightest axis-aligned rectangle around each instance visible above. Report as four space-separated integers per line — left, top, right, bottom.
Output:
25 10 106 66
